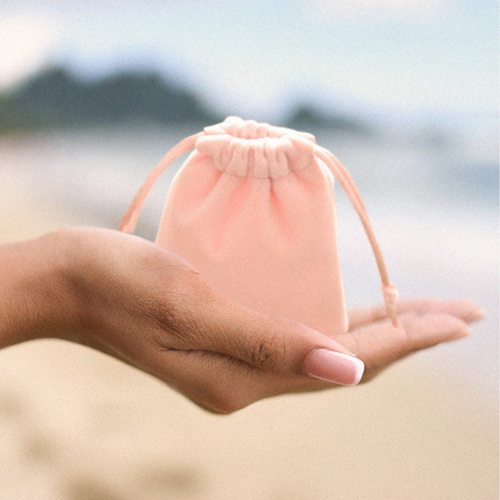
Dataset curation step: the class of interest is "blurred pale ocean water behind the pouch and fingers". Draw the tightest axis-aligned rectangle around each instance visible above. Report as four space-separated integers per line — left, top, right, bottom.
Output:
0 117 499 405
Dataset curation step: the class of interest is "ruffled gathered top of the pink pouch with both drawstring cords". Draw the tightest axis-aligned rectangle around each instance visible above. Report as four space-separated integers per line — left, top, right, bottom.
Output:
120 117 398 326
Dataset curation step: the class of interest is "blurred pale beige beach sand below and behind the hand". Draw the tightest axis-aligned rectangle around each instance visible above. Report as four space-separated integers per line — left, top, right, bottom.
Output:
0 178 498 500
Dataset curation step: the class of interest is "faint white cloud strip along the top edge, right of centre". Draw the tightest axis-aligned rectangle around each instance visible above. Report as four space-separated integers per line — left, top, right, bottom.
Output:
310 0 446 20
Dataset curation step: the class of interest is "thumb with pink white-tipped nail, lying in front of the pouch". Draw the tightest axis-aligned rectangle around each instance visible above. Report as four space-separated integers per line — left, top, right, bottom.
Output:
164 291 364 385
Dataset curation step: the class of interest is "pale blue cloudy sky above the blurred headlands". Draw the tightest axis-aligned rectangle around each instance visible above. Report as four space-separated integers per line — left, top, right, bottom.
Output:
0 0 499 118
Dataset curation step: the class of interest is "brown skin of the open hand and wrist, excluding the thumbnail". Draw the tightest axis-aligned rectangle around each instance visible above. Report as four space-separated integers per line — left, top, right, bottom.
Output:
0 227 483 414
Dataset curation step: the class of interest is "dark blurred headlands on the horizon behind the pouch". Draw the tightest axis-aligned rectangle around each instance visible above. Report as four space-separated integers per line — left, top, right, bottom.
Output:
0 66 373 135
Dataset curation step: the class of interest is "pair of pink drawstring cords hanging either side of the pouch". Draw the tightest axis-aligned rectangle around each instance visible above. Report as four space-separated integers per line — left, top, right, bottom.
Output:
119 132 398 327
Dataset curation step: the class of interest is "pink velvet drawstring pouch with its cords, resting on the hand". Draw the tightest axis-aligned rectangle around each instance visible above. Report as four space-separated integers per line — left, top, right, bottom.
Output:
120 117 397 336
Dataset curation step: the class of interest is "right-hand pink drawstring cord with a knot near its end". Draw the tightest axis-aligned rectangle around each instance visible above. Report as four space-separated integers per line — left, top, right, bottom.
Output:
315 146 399 327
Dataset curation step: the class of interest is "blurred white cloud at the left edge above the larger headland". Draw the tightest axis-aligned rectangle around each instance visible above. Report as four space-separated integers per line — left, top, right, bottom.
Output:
0 16 57 88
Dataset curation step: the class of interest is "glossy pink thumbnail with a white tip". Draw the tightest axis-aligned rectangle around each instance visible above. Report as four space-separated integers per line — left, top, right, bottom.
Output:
303 349 365 385
